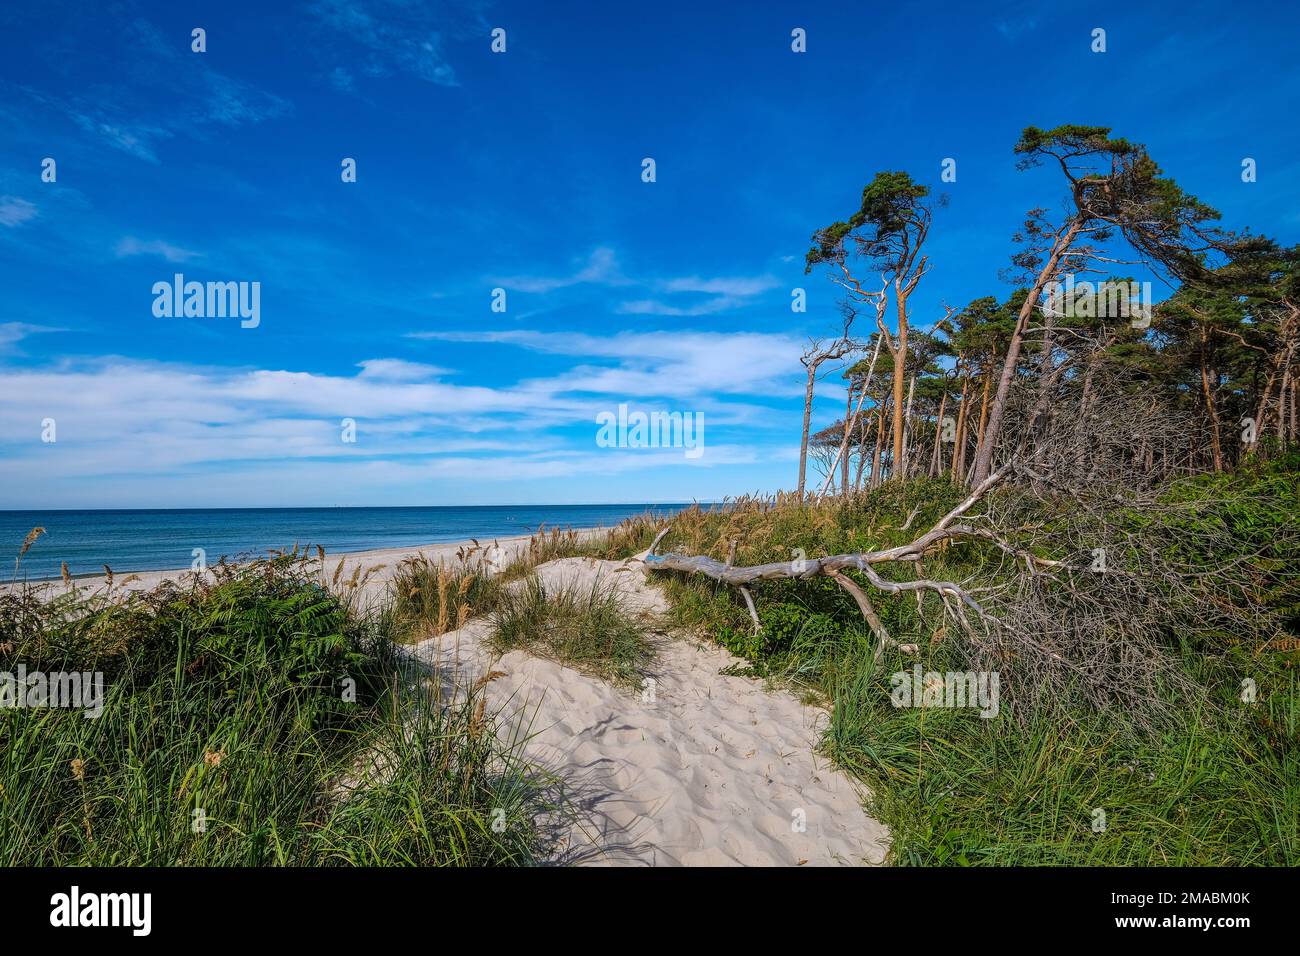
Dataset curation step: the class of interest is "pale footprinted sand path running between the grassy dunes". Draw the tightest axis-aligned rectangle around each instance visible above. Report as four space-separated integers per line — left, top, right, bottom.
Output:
411 558 888 866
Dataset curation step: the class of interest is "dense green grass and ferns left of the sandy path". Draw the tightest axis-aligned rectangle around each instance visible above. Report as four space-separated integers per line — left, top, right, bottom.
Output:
0 555 542 866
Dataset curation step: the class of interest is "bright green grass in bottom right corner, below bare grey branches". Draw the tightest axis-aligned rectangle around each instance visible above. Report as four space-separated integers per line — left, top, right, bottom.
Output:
826 642 1300 866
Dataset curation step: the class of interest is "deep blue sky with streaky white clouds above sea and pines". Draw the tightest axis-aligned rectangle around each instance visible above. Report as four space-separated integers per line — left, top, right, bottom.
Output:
0 0 1300 507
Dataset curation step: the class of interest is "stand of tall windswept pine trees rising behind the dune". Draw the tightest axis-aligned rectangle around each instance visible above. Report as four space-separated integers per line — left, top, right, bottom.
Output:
798 125 1300 494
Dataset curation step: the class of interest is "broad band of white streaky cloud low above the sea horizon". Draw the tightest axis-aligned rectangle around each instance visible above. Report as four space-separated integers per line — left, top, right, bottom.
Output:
0 329 798 506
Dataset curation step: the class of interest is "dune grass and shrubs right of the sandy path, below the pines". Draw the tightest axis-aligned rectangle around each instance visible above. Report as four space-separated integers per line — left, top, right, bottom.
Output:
634 454 1300 866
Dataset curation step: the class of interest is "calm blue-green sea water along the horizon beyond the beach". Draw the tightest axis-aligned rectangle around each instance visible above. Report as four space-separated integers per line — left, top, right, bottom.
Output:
0 505 685 580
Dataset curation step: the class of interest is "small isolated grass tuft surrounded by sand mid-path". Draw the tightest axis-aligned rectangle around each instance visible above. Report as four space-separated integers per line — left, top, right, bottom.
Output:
491 574 655 687
